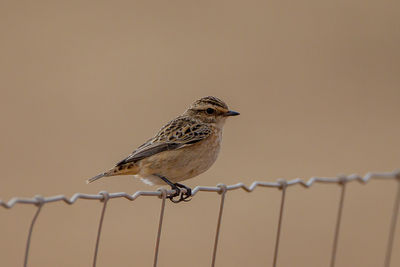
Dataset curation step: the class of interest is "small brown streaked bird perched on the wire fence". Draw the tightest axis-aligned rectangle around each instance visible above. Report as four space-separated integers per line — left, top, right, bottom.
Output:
87 96 240 203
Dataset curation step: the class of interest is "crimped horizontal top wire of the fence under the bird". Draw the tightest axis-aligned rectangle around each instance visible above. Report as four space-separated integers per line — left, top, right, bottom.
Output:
0 170 400 209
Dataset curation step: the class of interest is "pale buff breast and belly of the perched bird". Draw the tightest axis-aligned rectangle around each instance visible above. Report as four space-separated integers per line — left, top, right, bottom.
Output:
136 132 222 184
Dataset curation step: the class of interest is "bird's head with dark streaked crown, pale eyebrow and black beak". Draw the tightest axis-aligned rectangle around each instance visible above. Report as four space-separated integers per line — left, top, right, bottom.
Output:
184 96 240 127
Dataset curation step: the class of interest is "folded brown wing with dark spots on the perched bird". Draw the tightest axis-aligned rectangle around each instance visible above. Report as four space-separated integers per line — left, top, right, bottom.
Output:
117 117 212 166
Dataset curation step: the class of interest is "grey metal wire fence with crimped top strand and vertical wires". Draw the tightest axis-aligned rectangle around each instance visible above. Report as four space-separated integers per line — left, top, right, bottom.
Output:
0 170 400 267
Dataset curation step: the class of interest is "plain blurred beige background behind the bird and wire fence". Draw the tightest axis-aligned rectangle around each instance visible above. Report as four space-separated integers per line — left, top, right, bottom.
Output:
0 0 400 267
